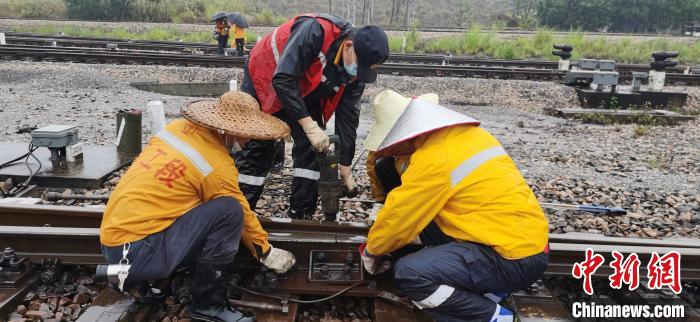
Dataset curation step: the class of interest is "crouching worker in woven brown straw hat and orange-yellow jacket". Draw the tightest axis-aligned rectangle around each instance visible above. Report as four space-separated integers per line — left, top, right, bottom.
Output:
100 92 295 321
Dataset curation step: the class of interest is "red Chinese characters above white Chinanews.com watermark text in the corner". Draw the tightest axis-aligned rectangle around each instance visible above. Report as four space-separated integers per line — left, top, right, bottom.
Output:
571 248 685 319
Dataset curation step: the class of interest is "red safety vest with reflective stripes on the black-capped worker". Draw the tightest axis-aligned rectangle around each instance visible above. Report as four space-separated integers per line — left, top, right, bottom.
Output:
248 14 352 122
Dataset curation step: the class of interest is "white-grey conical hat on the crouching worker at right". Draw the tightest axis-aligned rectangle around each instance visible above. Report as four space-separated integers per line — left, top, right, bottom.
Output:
377 100 479 155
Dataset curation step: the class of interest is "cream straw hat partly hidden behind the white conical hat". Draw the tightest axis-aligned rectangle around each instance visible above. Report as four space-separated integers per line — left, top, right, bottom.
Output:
365 89 438 151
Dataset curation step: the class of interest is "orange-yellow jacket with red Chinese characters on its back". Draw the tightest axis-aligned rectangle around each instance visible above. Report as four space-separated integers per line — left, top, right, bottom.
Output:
100 119 270 256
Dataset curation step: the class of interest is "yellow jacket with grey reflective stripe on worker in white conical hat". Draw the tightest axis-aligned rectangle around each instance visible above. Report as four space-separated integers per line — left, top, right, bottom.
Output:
366 125 548 259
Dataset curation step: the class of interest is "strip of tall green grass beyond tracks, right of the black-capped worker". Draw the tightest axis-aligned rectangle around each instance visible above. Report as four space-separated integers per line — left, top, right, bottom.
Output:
389 26 700 63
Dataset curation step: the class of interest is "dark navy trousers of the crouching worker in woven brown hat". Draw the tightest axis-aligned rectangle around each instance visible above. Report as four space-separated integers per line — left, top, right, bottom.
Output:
102 197 243 284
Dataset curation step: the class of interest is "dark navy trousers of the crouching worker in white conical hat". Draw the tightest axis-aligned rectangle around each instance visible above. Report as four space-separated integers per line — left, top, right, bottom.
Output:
394 242 549 322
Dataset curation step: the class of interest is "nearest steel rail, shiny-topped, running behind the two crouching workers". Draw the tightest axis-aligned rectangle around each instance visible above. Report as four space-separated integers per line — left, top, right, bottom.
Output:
0 226 700 281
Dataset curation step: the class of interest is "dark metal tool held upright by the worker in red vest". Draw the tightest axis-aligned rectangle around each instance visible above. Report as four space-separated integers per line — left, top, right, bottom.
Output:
317 135 346 221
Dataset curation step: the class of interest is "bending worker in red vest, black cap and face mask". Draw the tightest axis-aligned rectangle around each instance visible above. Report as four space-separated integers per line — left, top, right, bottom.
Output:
236 14 389 219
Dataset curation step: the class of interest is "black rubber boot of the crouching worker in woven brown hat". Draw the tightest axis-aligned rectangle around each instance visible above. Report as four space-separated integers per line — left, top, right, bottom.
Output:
190 263 255 322
